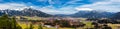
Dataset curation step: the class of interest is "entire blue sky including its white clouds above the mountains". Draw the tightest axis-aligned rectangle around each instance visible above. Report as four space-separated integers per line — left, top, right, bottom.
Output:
0 0 120 14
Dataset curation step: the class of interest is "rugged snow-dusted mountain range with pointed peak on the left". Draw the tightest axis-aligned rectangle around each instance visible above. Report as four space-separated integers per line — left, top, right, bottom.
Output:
0 8 52 17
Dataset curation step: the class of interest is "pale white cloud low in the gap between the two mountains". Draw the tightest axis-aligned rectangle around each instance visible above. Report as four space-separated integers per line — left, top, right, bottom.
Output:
40 6 77 15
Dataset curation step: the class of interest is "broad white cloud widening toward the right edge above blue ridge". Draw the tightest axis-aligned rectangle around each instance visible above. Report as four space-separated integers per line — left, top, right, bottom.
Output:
76 0 120 12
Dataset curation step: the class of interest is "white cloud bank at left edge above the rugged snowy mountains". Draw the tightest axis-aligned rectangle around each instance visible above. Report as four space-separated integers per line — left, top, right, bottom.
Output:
0 3 27 10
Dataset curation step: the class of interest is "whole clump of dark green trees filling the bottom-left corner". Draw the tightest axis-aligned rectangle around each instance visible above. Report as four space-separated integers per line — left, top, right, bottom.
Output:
0 15 21 29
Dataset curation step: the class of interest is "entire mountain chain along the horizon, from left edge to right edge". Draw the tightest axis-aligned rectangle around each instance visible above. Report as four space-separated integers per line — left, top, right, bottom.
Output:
0 8 120 18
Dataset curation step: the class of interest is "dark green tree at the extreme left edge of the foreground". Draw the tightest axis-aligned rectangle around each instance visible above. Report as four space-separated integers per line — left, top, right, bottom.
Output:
0 15 12 29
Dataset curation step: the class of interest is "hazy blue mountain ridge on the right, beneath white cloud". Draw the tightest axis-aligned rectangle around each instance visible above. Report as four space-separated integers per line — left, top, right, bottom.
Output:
56 11 114 18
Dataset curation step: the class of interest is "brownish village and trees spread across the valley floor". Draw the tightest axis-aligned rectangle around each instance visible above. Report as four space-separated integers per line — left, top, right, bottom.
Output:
15 17 119 29
